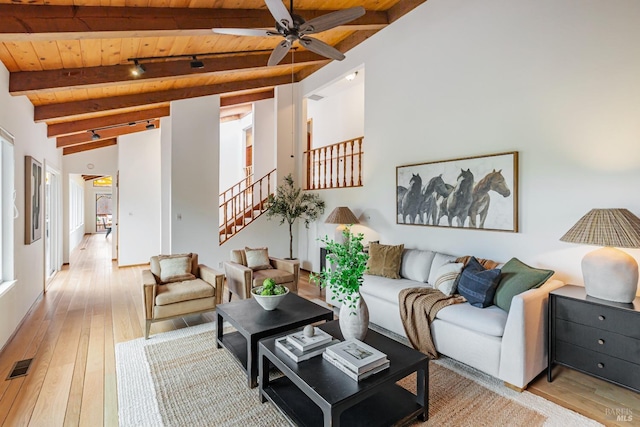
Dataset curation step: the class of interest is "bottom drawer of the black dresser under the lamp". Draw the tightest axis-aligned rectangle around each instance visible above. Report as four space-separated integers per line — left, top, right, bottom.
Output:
555 341 640 391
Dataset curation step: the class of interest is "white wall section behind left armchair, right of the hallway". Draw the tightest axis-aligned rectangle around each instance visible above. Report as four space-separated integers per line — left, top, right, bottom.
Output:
118 129 161 266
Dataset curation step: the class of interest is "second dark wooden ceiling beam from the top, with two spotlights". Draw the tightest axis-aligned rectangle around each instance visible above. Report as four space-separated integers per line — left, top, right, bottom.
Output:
9 51 326 95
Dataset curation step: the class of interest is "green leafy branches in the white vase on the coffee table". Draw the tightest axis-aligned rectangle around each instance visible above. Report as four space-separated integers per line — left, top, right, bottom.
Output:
309 227 369 312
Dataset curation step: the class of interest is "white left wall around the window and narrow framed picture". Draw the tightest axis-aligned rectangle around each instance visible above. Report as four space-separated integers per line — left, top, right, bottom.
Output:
0 64 62 348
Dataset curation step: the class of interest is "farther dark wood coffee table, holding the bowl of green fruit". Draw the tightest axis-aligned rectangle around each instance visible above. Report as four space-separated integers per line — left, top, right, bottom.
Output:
216 292 333 388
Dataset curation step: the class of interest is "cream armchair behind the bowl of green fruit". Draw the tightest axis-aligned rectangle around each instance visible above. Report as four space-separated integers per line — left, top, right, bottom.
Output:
224 248 300 301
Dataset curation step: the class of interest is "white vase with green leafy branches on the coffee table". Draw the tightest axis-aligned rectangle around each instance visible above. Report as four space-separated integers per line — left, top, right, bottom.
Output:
309 227 369 340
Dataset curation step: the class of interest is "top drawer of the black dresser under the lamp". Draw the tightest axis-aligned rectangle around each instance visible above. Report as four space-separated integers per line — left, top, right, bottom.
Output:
555 297 640 339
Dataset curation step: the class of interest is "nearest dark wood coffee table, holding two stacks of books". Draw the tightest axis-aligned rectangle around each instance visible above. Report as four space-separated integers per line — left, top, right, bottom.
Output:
259 321 429 427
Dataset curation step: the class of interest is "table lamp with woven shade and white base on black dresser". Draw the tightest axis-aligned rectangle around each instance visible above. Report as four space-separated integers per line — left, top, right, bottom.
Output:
560 209 640 303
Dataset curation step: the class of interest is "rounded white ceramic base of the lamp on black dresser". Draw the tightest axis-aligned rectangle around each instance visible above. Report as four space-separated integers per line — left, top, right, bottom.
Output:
582 247 638 303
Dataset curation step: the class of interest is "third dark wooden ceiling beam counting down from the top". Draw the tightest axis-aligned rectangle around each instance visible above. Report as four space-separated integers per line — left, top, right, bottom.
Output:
34 76 296 122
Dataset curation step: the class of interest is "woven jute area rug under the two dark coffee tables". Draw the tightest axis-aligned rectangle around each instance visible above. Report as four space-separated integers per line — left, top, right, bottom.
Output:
116 323 600 427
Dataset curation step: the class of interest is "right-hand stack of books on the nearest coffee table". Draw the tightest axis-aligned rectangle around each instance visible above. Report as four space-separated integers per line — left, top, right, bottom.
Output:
322 339 389 381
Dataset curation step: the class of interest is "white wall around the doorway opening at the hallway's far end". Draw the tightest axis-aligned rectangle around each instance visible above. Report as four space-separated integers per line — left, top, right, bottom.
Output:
62 145 118 263
